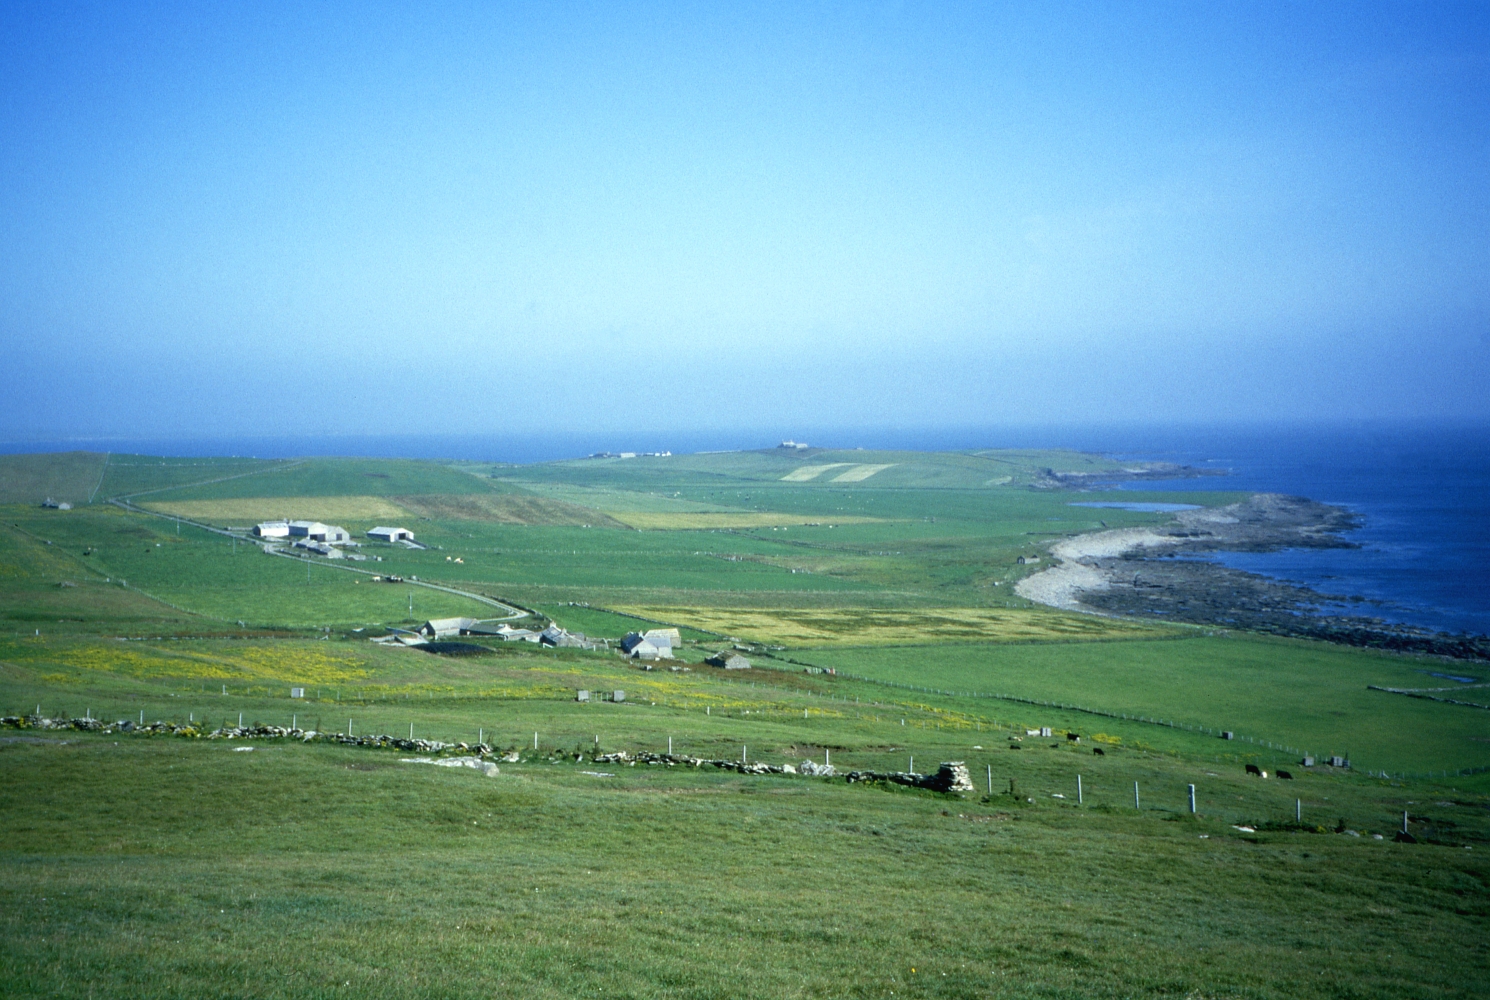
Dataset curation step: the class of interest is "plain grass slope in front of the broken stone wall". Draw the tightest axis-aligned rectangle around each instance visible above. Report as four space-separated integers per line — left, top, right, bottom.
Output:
0 727 1490 997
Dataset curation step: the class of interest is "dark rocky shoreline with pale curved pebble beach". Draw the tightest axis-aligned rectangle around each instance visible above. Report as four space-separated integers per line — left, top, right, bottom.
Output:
1015 493 1490 660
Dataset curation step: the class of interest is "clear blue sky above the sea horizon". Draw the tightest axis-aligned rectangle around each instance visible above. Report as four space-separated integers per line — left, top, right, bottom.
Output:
0 3 1490 437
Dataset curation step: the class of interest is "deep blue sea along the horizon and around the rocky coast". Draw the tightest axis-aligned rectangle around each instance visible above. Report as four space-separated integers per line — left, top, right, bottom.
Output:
0 423 1490 635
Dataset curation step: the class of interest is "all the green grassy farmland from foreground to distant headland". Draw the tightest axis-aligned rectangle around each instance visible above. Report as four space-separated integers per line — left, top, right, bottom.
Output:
0 449 1490 999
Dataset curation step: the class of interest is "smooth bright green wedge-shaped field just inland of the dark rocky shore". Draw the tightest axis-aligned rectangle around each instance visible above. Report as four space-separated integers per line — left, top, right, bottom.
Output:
793 630 1490 772
